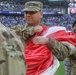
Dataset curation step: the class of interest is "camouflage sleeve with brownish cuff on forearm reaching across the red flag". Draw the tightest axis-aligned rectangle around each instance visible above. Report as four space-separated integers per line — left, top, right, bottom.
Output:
47 39 76 60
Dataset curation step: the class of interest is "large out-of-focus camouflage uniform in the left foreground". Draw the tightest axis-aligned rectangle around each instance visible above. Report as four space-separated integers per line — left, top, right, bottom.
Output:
0 24 26 75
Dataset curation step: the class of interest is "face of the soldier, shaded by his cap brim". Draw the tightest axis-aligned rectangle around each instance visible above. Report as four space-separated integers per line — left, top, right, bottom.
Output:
24 11 43 25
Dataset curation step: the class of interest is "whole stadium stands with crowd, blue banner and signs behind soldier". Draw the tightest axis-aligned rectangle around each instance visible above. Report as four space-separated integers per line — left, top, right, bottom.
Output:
0 0 76 30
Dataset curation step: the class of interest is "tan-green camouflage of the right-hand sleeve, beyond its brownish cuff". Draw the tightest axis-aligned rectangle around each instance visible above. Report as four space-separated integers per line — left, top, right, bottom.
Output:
53 41 76 60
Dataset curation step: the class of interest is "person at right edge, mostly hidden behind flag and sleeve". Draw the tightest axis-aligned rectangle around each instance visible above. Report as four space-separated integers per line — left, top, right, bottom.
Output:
64 21 76 75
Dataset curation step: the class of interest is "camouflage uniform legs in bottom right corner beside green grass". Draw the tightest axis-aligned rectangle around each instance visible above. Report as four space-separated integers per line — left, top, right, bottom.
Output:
64 58 76 75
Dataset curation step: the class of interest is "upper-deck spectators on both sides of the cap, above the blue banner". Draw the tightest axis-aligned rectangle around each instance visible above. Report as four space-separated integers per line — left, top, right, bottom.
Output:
0 1 63 13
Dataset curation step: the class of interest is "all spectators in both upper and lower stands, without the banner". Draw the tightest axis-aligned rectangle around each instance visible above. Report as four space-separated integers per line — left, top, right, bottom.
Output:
0 1 76 30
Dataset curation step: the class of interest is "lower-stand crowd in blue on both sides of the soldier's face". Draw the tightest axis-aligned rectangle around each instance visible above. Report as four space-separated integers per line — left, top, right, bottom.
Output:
0 14 76 30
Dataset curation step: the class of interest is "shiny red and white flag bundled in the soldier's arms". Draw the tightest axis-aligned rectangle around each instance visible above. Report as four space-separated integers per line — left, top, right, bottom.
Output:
25 26 76 75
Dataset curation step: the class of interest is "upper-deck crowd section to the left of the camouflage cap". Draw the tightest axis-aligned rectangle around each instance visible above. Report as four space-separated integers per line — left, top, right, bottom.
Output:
0 1 24 11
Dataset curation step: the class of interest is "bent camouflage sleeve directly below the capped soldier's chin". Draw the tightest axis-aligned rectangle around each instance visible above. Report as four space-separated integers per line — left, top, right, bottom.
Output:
11 24 34 40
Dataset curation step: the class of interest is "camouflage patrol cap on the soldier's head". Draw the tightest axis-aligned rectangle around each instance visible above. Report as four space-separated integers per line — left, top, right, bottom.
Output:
22 1 43 11
